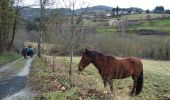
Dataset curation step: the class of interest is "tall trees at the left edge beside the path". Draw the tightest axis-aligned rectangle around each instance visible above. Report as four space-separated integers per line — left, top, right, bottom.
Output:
0 0 27 55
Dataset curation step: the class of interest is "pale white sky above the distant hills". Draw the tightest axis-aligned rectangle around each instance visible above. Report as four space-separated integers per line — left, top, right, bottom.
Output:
24 0 170 10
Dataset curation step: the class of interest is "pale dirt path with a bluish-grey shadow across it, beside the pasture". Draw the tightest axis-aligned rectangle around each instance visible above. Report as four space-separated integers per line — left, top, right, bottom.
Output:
0 58 33 100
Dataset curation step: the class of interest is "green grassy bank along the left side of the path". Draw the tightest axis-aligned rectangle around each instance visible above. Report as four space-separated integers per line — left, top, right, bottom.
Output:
0 52 22 66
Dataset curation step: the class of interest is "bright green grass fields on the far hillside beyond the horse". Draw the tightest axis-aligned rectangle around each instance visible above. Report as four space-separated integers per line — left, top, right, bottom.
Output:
91 15 170 34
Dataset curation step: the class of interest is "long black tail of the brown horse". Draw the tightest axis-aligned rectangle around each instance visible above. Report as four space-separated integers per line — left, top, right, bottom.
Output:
135 71 143 95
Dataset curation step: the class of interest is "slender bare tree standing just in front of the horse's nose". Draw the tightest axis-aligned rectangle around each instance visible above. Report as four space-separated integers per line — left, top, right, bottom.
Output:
57 0 88 80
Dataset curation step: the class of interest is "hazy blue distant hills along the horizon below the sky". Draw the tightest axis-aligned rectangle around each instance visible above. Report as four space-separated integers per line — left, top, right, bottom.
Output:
21 5 143 20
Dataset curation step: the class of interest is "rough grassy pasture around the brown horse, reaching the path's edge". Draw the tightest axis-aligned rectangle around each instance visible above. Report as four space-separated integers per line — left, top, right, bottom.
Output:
30 57 170 100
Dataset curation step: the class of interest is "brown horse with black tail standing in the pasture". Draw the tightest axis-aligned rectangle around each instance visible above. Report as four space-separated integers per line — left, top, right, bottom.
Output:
78 49 143 96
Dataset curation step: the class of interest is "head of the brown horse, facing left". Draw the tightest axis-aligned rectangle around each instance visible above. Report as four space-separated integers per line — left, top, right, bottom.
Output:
78 49 94 71
